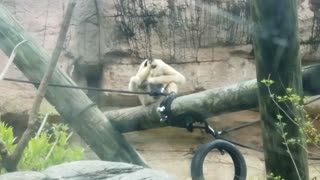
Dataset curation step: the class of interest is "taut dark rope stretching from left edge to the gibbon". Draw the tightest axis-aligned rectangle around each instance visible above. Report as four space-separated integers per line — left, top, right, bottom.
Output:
3 78 168 96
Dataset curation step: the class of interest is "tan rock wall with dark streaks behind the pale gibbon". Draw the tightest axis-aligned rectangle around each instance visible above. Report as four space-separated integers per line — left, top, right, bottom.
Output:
0 0 319 108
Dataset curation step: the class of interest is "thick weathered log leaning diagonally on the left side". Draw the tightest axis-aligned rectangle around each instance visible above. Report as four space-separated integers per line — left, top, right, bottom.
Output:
0 5 146 166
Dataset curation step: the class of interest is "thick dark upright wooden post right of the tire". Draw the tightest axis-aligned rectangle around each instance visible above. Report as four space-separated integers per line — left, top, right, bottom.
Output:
251 0 309 180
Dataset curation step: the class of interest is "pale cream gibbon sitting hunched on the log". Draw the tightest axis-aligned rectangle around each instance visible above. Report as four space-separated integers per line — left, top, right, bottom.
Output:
129 59 186 106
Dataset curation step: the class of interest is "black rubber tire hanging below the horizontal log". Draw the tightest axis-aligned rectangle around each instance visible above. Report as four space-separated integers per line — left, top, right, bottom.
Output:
191 139 247 180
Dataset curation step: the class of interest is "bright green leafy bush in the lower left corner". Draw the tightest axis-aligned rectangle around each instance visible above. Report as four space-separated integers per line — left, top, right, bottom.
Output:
1 123 84 170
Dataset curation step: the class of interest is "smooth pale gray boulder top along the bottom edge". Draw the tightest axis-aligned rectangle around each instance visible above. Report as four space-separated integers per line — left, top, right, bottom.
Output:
0 160 175 180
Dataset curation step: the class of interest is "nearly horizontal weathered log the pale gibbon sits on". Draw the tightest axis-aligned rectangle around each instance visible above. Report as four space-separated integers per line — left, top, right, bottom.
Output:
104 65 320 133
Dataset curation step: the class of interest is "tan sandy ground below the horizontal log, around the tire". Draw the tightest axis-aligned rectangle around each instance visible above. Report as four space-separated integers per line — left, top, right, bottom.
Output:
77 111 320 180
